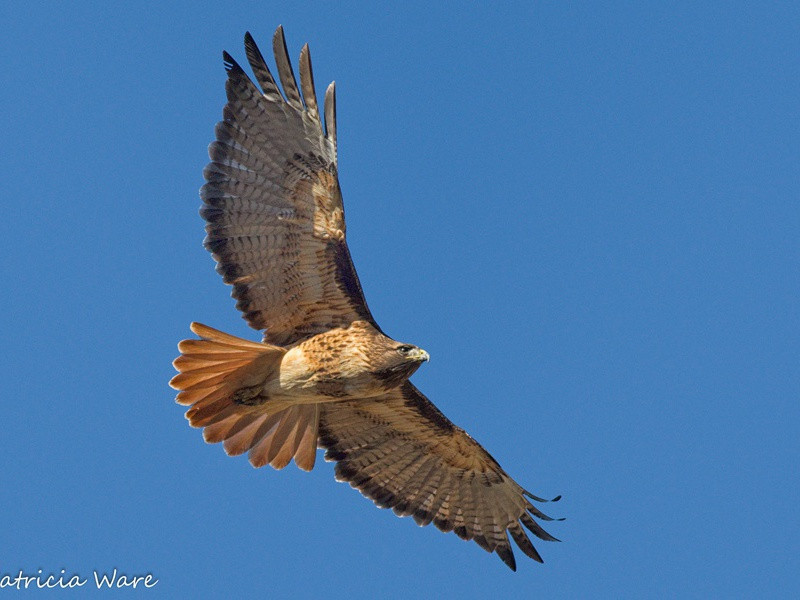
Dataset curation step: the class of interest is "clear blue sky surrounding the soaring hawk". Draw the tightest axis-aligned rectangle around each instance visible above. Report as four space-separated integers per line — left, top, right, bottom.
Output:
0 2 800 598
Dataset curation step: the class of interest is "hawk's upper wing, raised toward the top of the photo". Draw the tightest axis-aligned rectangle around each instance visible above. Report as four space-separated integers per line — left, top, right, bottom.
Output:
200 27 377 345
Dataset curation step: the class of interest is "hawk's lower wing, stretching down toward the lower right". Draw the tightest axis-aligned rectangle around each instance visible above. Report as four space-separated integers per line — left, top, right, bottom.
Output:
319 382 557 570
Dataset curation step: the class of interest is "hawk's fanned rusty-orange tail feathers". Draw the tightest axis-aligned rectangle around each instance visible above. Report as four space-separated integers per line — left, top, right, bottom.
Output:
170 323 319 471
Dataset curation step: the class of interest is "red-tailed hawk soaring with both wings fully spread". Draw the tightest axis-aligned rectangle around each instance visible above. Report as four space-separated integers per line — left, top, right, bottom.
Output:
170 27 555 569
